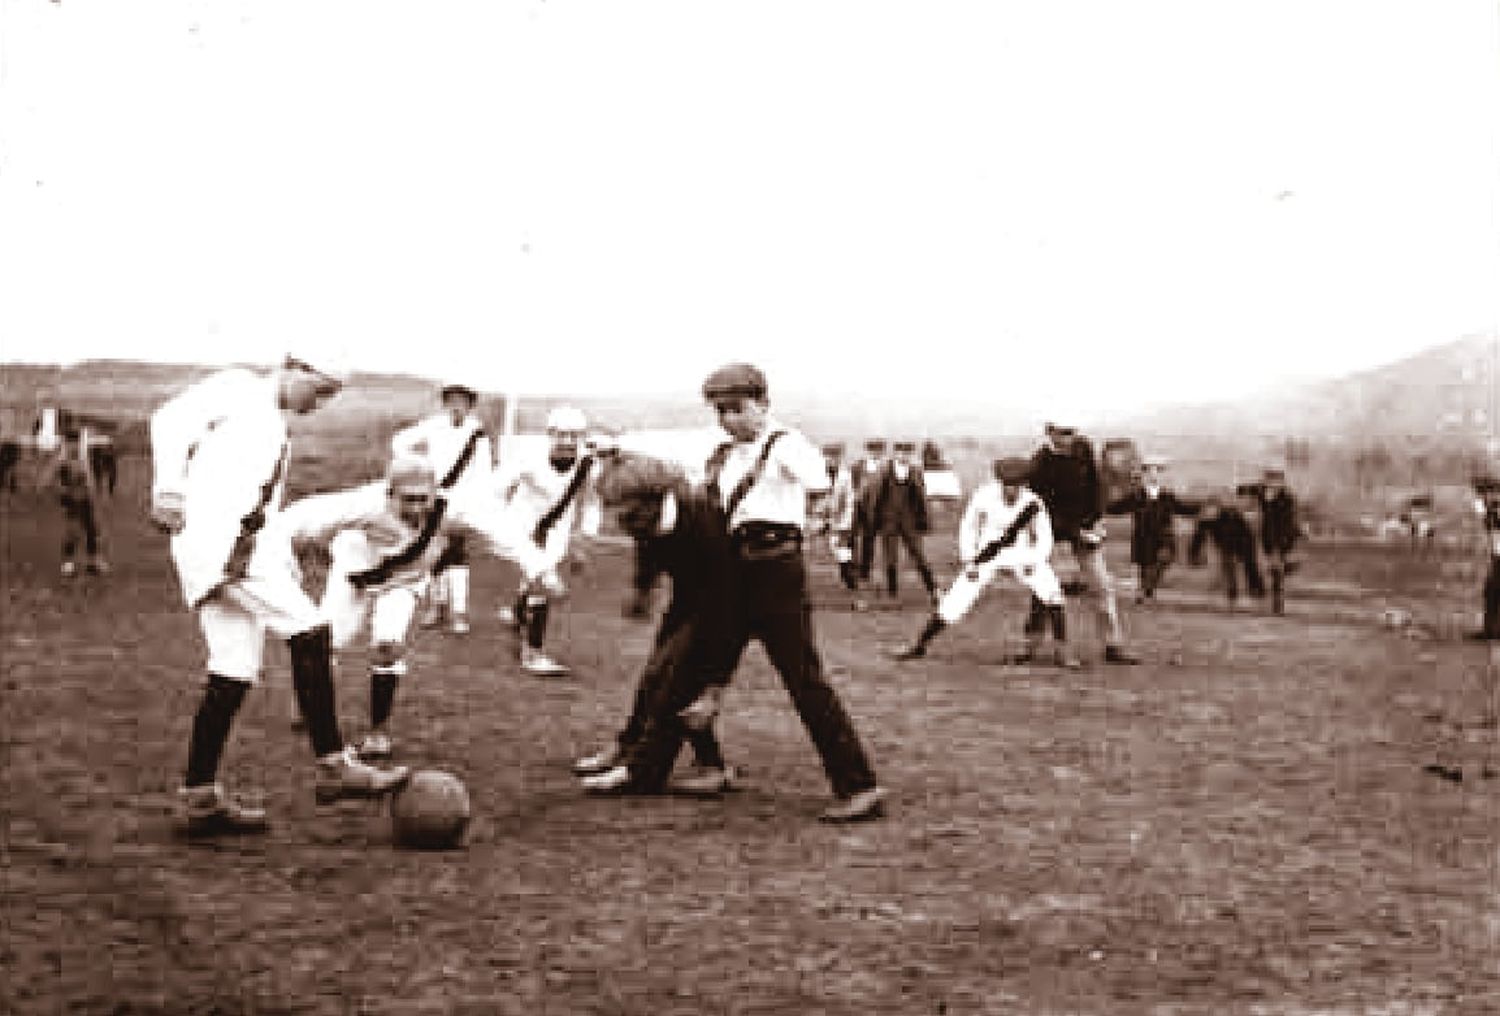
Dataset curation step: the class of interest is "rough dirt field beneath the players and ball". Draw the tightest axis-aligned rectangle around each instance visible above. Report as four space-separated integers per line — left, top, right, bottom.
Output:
0 462 1500 1016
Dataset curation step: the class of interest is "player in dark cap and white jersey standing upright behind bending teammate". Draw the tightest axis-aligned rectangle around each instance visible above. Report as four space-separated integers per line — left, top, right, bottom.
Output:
390 381 495 635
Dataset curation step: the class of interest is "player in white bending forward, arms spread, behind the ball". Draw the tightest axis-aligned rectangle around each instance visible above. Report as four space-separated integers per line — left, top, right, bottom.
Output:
279 456 548 758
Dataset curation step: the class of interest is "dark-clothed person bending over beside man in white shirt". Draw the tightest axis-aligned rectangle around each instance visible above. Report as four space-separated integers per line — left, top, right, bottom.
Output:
573 461 734 795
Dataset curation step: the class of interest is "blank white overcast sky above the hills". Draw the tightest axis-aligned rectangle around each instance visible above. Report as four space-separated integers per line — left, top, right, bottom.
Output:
0 0 1500 411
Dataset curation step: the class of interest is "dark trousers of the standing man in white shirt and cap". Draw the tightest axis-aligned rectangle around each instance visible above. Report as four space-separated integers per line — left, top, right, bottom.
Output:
722 540 876 797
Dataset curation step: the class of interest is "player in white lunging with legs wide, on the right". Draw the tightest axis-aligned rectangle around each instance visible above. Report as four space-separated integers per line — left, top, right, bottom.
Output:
896 458 1079 668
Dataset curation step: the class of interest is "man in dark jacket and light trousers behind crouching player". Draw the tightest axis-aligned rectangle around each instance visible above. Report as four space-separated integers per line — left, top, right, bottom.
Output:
1031 423 1140 663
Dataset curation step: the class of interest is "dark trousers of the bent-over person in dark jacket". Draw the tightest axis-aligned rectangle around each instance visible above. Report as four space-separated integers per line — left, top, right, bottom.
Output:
618 611 726 789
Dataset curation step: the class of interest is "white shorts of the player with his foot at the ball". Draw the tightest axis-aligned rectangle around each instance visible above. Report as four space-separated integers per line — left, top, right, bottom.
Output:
197 569 324 683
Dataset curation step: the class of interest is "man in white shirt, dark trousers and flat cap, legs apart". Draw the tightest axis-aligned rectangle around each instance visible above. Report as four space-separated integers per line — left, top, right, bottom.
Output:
704 363 885 822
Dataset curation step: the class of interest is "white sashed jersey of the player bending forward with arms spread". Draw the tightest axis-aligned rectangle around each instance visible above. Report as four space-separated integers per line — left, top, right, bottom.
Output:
276 480 543 591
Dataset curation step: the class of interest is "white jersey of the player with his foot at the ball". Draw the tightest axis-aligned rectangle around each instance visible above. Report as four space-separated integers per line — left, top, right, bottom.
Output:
150 369 290 606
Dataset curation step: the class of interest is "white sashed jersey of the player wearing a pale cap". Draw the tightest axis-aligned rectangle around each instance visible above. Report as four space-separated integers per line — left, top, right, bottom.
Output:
495 446 605 566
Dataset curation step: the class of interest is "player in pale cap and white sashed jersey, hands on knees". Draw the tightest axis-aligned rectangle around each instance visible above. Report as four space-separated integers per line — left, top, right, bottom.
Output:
495 405 603 677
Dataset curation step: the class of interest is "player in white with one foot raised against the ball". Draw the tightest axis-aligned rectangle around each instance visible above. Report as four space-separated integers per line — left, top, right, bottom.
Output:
150 354 410 836
